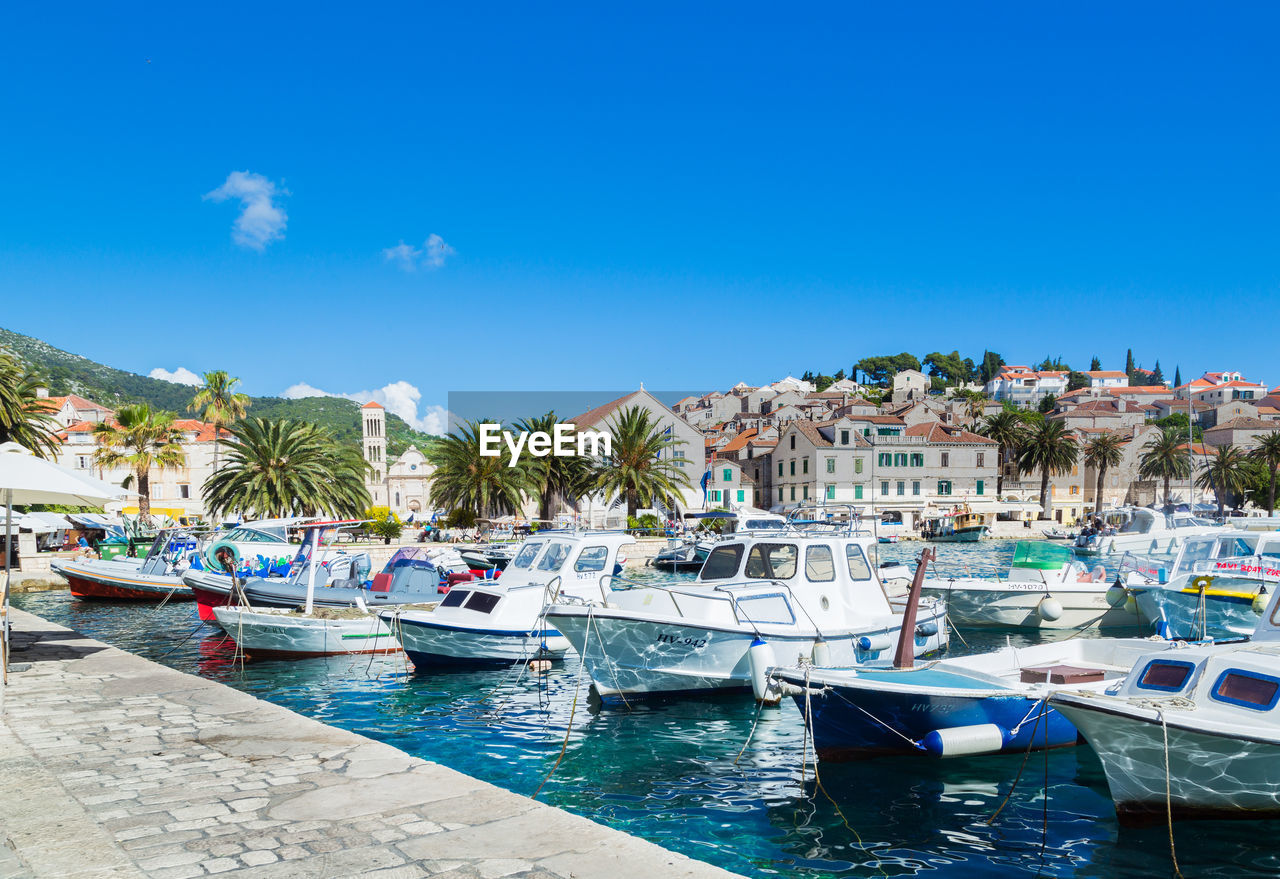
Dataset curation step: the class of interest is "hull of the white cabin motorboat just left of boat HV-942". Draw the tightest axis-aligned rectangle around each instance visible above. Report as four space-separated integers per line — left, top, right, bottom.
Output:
383 613 570 668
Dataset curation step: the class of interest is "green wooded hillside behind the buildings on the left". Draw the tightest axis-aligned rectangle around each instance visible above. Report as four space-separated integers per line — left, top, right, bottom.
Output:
0 328 436 457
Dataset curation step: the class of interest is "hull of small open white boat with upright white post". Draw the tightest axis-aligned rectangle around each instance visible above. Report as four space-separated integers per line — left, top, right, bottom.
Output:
214 606 401 659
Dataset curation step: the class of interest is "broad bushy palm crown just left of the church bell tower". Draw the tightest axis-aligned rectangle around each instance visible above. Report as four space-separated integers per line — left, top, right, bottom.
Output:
204 418 371 518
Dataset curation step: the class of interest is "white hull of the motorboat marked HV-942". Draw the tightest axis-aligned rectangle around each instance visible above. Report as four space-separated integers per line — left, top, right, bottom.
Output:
547 606 946 697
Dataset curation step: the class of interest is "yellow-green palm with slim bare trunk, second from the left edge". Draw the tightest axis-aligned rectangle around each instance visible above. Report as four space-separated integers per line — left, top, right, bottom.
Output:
93 403 187 518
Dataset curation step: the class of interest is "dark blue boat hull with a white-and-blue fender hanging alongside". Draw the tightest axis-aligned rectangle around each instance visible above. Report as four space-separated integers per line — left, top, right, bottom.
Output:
783 669 1079 761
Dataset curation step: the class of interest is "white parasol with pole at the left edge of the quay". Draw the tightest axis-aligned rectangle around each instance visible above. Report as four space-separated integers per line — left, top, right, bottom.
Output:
0 443 124 683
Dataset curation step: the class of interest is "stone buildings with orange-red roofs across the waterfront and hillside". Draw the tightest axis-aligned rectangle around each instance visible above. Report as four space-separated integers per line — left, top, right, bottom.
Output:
24 365 1280 527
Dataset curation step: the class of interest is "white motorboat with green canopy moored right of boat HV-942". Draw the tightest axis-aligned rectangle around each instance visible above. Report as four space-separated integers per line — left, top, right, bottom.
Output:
924 540 1140 631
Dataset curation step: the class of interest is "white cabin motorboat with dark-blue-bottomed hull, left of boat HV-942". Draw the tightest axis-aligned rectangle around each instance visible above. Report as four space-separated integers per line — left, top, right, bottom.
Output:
380 531 635 668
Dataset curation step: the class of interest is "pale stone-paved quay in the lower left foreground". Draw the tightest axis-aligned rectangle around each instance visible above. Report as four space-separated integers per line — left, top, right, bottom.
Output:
0 610 733 879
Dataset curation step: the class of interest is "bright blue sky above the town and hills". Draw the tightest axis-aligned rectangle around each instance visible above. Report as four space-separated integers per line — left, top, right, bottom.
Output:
0 3 1280 429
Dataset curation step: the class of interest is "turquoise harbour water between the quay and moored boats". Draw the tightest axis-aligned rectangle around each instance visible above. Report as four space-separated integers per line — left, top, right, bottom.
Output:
14 541 1280 878
